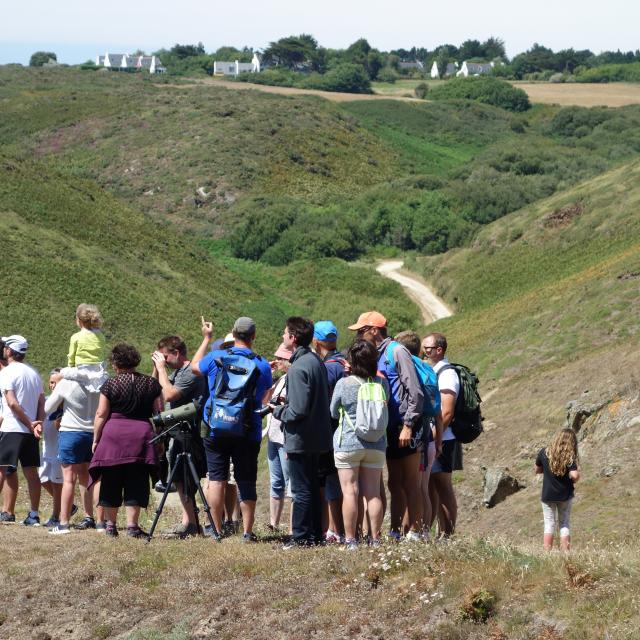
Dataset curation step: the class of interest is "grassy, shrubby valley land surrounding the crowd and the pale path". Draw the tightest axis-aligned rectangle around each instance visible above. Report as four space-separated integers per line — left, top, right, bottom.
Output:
0 69 640 640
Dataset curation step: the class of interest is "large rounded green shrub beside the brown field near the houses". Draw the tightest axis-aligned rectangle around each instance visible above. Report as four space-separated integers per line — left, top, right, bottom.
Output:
429 76 531 111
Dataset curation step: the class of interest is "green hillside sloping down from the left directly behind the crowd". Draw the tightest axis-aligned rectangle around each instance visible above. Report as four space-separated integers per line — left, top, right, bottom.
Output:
0 156 419 370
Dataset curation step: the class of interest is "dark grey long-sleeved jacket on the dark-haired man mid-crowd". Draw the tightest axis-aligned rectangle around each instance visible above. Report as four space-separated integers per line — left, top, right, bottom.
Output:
273 347 332 453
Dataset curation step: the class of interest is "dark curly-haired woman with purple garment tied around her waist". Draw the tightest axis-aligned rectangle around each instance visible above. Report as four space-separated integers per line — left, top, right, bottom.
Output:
89 344 162 538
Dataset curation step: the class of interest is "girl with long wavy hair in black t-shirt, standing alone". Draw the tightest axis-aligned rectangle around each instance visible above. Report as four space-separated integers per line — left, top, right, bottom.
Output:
536 429 580 551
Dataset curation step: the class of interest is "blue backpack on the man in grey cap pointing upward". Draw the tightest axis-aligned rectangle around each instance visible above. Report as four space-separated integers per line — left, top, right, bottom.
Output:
207 349 260 437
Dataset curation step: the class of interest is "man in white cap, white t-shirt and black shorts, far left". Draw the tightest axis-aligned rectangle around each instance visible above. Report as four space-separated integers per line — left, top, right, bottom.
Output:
0 335 44 526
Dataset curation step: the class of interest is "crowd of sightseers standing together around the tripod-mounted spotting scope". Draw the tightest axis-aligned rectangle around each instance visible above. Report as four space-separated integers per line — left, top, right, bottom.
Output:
0 304 577 550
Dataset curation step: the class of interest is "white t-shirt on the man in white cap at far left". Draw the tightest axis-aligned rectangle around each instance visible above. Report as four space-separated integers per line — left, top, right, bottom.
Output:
0 362 42 433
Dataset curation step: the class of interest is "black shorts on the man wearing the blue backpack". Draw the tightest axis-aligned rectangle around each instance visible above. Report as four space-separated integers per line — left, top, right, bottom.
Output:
204 438 260 500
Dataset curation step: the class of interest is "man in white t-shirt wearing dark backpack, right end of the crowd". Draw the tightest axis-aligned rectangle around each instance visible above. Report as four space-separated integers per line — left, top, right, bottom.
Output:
422 333 460 537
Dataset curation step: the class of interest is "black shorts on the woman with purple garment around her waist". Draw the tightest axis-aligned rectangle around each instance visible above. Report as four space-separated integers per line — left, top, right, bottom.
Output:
98 462 150 509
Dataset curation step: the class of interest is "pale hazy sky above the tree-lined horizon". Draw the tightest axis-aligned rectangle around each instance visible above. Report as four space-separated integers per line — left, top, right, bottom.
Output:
0 0 640 64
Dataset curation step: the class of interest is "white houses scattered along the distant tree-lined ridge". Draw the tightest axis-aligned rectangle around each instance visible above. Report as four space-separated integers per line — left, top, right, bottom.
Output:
95 52 495 78
